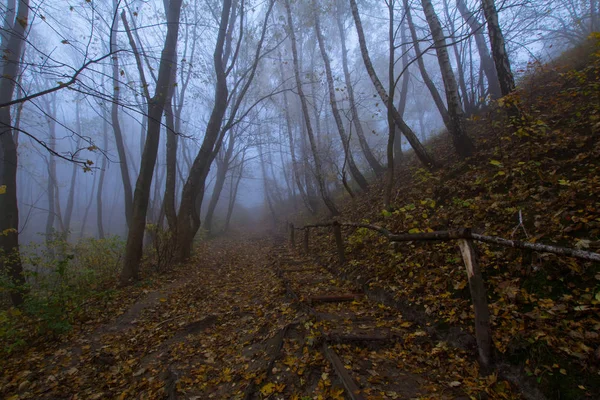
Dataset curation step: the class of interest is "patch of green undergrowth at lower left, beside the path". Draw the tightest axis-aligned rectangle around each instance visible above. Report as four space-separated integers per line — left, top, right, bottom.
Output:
0 235 124 353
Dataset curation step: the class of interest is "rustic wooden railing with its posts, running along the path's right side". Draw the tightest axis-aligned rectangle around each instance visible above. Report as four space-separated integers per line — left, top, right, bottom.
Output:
289 221 600 369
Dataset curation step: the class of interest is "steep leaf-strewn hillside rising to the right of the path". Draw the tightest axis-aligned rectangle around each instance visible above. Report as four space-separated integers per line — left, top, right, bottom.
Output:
296 39 600 399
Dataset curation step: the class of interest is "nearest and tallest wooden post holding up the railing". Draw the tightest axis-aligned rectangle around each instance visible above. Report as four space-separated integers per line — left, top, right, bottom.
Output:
458 239 493 373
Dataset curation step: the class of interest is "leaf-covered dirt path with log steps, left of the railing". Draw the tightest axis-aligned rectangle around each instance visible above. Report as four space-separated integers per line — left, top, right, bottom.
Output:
0 238 492 399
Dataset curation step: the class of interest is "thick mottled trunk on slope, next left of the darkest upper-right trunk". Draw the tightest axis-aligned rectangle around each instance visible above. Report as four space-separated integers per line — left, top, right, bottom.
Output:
421 0 475 158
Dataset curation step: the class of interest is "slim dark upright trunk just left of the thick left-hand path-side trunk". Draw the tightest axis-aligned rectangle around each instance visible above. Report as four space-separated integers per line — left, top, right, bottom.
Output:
110 0 133 227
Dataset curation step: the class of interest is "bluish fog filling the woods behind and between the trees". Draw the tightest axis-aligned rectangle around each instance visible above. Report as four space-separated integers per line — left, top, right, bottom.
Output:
0 0 597 250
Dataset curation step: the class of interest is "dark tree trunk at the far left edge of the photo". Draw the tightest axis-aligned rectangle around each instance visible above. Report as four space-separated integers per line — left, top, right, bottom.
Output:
0 0 29 306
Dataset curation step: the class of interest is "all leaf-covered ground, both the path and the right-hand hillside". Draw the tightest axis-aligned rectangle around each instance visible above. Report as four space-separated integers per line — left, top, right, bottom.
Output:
0 29 600 400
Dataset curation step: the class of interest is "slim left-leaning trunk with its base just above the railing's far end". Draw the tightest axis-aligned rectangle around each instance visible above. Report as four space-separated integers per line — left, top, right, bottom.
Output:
285 0 339 216
